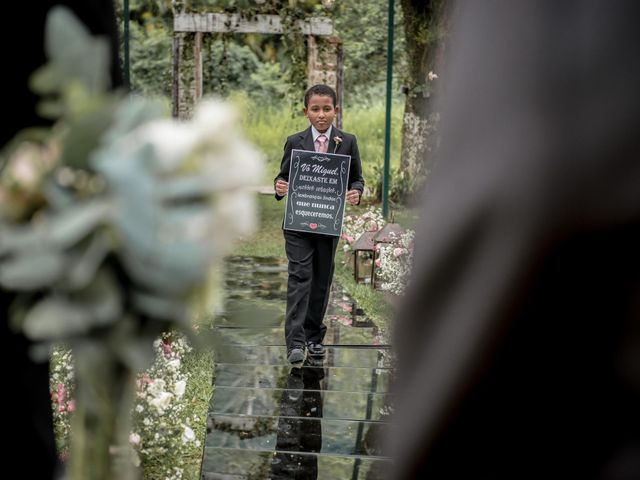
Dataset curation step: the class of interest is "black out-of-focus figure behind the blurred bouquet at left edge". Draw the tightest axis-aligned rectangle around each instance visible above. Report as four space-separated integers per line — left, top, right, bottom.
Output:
0 0 122 480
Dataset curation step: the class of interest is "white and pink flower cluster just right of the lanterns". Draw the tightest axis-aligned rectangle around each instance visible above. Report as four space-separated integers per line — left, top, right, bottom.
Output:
376 230 415 295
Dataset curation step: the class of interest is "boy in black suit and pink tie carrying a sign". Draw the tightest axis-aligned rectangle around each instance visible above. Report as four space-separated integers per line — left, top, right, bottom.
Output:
274 85 364 365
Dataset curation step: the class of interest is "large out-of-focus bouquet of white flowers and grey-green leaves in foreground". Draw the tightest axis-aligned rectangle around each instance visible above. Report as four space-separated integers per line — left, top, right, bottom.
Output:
0 7 263 479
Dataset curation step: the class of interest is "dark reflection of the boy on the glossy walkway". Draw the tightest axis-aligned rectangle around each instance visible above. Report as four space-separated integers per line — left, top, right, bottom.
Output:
269 358 325 480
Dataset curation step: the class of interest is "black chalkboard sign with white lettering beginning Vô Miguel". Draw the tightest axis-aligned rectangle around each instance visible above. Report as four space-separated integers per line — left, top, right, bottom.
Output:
284 150 351 236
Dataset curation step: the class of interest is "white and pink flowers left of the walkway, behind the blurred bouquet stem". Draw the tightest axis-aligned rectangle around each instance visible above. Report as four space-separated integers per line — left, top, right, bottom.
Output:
50 334 205 480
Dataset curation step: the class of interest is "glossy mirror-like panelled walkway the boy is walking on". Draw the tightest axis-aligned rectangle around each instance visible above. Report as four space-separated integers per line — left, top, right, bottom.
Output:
201 257 392 480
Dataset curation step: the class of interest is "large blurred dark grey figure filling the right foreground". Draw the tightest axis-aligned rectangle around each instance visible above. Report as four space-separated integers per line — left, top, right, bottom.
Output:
390 0 640 480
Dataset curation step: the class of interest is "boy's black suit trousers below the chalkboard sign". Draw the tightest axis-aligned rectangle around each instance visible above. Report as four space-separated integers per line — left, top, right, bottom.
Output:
283 230 338 350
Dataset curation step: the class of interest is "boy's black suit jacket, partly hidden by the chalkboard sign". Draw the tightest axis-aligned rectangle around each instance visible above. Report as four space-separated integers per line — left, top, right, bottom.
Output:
273 127 364 200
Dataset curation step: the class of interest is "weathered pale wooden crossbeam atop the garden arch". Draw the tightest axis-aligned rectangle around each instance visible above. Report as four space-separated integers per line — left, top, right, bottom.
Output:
173 13 333 37
